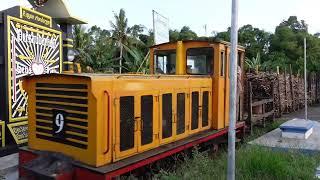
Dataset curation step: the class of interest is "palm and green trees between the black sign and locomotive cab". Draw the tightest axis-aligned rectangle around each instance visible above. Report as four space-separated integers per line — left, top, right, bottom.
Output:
73 9 153 73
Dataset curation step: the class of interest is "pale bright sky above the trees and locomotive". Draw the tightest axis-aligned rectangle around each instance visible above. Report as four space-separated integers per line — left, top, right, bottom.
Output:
0 0 320 36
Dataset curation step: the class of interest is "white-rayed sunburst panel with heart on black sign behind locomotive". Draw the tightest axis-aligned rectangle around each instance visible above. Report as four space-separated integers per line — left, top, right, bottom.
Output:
8 18 61 121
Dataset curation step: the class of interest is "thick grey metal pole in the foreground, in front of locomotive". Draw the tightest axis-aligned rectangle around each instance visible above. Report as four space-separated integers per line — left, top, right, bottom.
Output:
227 0 238 180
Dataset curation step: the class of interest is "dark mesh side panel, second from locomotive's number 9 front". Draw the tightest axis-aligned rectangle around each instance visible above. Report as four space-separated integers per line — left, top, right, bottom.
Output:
141 95 153 145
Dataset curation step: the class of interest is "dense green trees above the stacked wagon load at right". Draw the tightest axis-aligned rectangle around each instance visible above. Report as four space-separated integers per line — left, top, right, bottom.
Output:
215 16 320 72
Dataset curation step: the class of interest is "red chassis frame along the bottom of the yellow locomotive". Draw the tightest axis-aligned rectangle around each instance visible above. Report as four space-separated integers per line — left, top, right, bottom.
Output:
19 122 245 180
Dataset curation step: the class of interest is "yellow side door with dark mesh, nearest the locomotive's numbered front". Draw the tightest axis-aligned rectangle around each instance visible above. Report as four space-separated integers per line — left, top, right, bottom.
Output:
115 94 139 160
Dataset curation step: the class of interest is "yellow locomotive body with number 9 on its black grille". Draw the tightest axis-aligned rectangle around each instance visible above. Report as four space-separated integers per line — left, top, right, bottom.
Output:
24 41 244 167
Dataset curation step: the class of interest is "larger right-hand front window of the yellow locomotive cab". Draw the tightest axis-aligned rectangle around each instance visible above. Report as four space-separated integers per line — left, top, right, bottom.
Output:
187 48 213 75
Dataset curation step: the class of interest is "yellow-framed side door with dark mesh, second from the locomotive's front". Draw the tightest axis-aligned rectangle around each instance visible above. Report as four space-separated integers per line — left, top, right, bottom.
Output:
137 91 159 152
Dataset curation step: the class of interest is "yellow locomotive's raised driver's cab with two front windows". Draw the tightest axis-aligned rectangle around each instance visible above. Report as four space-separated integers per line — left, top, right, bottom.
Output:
150 40 244 129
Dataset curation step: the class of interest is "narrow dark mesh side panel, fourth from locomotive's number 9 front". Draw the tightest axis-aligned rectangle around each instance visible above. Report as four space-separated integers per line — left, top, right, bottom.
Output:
177 93 186 134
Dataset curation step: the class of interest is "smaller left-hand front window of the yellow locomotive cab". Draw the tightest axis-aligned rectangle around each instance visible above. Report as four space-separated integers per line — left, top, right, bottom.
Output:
154 50 176 74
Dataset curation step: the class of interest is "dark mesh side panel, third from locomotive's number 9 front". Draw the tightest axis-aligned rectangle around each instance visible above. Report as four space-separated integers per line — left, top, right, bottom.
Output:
162 94 172 139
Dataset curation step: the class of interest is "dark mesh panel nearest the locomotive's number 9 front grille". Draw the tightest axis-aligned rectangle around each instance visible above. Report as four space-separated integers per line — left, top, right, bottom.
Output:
120 96 135 151
